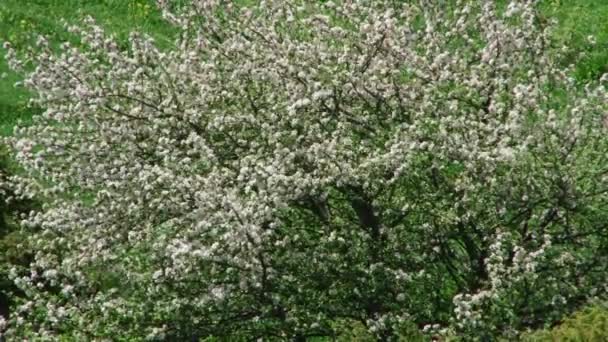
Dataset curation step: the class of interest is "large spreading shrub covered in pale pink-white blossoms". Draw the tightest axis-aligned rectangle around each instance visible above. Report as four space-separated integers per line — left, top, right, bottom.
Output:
6 0 608 341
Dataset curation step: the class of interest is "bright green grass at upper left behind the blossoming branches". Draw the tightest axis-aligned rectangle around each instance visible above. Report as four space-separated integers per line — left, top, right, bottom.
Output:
0 0 174 136
